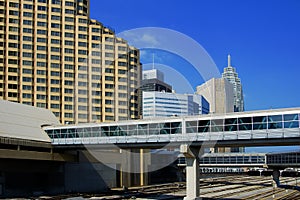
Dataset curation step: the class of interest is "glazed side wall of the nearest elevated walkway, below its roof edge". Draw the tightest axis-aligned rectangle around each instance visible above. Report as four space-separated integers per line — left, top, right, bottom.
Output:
44 110 300 144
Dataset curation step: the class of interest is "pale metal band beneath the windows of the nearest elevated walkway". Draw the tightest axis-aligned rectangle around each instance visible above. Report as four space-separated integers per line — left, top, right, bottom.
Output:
52 128 300 145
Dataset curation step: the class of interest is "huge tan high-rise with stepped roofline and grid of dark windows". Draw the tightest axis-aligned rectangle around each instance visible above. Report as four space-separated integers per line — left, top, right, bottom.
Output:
0 0 141 123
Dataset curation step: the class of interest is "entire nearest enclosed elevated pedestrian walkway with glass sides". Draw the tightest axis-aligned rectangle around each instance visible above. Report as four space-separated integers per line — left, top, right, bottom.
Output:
43 108 300 148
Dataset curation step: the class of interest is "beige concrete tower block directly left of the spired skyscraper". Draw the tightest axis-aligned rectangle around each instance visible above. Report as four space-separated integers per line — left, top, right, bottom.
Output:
196 78 234 113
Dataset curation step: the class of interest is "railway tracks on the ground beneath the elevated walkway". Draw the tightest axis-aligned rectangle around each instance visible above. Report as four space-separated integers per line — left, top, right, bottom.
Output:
31 176 300 200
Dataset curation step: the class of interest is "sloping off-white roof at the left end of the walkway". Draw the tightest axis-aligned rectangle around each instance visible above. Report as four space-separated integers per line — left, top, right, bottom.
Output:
0 100 60 142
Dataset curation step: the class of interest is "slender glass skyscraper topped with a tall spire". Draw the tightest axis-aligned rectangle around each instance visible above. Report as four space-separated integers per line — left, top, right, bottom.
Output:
222 55 244 112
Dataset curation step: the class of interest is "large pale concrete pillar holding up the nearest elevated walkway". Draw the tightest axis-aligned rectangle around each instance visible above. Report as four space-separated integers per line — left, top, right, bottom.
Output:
180 144 200 200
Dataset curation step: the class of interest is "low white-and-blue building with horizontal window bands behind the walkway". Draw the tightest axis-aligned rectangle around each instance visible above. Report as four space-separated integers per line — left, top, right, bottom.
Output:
143 92 209 119
